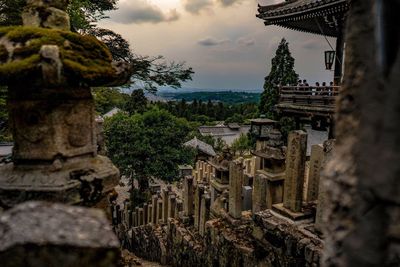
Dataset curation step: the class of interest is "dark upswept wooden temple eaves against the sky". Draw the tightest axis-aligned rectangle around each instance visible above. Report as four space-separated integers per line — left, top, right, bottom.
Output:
257 0 349 37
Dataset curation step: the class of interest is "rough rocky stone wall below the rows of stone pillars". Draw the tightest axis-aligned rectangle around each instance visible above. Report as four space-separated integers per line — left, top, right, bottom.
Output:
116 211 322 267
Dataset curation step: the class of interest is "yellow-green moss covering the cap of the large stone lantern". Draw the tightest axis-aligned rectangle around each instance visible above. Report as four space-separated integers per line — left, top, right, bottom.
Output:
0 26 115 86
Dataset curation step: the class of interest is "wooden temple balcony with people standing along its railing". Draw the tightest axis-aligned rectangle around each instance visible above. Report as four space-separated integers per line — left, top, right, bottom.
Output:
276 86 340 117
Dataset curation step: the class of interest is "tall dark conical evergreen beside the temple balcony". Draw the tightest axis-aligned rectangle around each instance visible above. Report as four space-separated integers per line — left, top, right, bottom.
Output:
259 39 299 119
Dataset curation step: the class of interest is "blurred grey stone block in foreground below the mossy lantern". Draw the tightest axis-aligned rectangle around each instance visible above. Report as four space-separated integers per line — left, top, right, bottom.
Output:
0 202 120 267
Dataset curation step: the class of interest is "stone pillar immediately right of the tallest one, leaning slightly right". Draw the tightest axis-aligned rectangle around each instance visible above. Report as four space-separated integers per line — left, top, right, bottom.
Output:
307 145 325 202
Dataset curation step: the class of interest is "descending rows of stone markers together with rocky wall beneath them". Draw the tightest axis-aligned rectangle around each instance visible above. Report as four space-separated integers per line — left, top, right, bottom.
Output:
112 131 333 266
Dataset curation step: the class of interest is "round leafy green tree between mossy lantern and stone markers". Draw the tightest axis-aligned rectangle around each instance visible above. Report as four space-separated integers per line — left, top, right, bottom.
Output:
105 108 194 192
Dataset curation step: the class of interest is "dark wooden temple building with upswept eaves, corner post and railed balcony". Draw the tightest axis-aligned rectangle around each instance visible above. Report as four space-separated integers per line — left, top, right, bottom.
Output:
257 0 350 135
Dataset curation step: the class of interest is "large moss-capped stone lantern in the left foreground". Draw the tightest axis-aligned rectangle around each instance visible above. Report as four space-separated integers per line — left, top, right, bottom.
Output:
0 0 131 208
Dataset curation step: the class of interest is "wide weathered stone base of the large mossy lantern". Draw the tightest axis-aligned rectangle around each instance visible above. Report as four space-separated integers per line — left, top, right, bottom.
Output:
0 156 119 208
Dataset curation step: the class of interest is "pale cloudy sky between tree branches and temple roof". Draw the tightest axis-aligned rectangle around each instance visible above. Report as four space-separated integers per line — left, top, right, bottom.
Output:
99 0 335 90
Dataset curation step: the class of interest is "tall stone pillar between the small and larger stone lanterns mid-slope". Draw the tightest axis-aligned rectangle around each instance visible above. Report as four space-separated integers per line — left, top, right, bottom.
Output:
229 158 243 219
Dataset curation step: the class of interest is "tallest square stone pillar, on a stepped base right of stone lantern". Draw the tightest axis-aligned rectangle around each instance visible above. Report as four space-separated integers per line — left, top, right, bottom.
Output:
283 131 307 212
